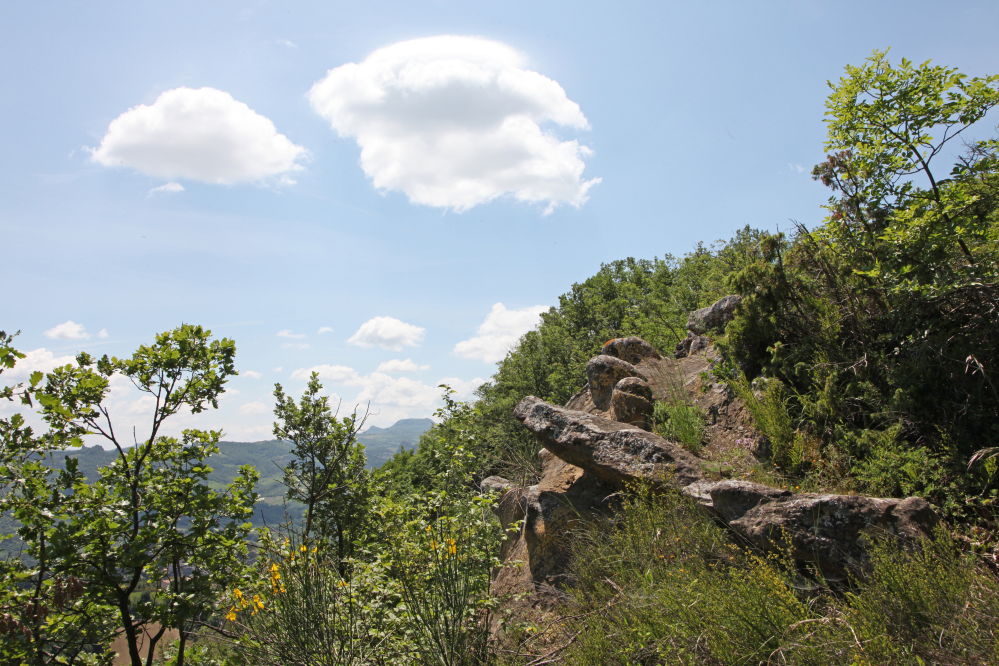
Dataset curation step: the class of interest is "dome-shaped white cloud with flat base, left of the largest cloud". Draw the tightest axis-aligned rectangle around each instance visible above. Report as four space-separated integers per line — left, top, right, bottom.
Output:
91 88 306 184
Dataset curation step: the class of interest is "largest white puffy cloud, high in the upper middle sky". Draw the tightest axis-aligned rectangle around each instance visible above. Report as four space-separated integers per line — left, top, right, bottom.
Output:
309 35 600 212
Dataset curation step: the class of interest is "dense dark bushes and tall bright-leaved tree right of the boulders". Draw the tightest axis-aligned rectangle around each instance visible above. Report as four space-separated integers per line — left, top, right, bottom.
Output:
723 51 999 516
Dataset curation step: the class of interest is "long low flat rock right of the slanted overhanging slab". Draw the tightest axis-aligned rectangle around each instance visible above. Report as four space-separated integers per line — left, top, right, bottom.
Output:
683 481 939 580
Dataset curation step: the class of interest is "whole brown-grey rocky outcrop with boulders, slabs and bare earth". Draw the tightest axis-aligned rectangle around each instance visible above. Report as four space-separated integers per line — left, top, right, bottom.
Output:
482 332 938 637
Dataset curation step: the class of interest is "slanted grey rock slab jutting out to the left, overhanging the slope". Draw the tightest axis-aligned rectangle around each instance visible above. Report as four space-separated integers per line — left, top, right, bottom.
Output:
513 396 701 488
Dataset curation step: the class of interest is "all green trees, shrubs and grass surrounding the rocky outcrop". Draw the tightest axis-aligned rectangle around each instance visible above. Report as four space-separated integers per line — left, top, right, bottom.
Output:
0 53 999 666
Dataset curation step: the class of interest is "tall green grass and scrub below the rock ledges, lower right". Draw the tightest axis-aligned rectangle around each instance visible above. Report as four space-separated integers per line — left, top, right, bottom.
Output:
560 486 999 666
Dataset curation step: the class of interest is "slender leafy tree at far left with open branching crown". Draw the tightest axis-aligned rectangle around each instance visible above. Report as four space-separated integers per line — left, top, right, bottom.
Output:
4 324 258 666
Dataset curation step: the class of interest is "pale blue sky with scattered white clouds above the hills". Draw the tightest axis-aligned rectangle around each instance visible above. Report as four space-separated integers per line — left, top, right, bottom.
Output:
0 0 999 443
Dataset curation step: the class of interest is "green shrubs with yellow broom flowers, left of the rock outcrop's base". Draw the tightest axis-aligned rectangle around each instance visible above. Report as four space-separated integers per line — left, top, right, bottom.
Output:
222 391 500 666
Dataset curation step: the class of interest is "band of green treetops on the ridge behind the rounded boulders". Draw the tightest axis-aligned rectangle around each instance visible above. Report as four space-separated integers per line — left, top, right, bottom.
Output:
464 227 759 483
